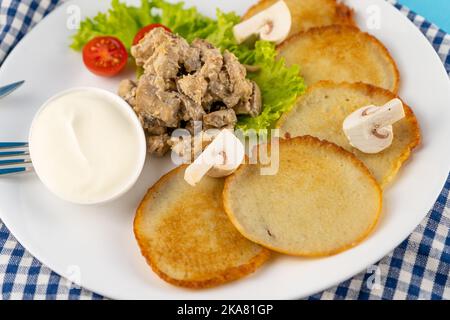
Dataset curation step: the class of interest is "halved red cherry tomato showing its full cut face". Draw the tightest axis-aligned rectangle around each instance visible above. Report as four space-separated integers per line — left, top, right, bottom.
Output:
83 36 128 77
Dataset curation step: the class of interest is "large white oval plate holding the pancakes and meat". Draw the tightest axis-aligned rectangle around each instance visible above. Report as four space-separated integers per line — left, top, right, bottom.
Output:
0 0 450 299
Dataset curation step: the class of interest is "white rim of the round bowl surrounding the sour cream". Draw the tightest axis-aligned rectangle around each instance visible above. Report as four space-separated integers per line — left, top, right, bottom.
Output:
28 87 147 205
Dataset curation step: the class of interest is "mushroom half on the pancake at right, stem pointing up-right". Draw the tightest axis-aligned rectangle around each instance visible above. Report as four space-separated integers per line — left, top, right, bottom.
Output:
343 98 405 154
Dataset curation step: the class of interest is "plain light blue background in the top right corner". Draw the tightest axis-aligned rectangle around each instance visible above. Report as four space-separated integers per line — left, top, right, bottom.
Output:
398 0 450 32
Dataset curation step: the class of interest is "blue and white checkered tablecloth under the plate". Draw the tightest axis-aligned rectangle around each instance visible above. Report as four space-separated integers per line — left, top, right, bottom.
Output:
0 0 450 300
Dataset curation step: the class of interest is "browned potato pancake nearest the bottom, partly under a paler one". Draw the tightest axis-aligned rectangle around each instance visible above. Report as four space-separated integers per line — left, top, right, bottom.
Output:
134 166 269 288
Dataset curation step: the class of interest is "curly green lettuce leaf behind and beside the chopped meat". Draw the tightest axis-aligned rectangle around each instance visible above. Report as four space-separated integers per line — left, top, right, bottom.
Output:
71 0 305 131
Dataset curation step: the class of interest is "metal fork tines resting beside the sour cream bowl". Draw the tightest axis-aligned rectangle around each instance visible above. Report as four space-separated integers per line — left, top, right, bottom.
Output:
0 142 33 176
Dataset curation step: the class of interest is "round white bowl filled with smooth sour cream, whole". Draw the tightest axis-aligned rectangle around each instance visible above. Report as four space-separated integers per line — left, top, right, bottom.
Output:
29 87 146 204
